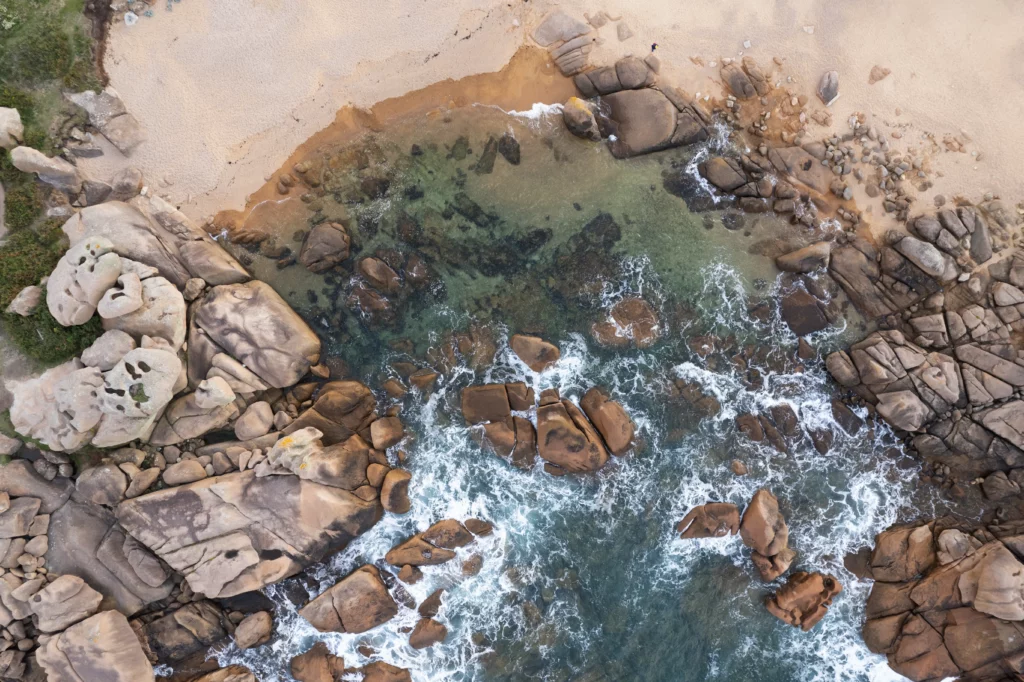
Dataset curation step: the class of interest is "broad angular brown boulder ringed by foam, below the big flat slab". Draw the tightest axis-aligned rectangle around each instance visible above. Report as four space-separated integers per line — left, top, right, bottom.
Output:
299 565 398 633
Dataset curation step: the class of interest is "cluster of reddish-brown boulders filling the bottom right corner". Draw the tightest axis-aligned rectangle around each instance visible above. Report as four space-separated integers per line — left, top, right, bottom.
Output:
863 517 1024 682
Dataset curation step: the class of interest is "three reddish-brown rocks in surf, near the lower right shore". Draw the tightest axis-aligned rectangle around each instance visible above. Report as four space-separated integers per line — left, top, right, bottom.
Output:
676 488 843 632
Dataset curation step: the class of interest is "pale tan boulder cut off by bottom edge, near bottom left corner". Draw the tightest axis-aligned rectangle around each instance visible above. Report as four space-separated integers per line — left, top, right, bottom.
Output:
36 611 156 682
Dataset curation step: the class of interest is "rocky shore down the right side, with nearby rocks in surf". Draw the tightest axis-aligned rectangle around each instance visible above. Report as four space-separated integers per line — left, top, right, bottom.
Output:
535 7 1024 682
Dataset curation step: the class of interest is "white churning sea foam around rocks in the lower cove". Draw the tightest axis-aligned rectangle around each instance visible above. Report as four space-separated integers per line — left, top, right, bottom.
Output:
218 259 937 682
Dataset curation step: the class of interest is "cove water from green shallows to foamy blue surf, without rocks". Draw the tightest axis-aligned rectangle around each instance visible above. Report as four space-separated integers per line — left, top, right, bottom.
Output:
220 103 932 682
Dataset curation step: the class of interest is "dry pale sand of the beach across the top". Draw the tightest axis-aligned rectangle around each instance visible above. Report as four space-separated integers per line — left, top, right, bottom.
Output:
83 0 1024 218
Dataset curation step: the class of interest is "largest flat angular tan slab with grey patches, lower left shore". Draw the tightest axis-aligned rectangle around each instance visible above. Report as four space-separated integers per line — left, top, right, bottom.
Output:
117 470 381 598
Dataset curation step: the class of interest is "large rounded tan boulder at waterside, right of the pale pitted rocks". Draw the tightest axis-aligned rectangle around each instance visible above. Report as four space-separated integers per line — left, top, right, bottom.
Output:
188 280 321 388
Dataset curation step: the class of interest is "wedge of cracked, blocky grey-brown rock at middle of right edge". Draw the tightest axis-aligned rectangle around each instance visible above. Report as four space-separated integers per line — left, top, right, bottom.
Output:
825 246 1024 491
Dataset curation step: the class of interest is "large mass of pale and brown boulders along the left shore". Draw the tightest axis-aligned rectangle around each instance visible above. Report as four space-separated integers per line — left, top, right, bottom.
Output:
0 116 436 682
